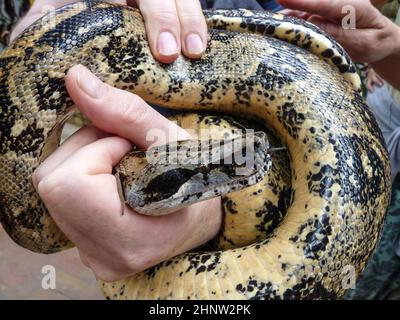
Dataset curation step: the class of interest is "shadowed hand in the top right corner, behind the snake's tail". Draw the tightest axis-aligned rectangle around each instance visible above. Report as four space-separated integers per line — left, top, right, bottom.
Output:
278 0 400 63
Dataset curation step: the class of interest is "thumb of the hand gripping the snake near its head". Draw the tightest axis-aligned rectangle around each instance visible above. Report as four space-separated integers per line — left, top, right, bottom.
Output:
66 66 190 147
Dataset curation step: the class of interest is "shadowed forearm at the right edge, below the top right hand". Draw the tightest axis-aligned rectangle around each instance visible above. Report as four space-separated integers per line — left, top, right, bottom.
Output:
371 26 400 90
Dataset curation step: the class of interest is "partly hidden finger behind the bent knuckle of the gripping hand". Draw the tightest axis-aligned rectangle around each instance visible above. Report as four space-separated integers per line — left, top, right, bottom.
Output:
32 125 109 188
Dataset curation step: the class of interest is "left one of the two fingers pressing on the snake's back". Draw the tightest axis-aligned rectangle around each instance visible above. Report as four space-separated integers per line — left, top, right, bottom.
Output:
136 0 181 63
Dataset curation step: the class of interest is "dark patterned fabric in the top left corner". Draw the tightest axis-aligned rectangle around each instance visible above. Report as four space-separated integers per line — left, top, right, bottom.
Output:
0 0 33 51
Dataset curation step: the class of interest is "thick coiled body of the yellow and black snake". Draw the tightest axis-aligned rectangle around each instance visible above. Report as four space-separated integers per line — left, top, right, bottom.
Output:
0 1 391 299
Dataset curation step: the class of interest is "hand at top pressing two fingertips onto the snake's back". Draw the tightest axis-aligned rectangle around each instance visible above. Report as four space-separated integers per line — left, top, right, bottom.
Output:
10 0 207 63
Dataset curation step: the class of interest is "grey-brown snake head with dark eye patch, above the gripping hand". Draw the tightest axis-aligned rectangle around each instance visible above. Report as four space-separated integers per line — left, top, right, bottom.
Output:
115 132 271 215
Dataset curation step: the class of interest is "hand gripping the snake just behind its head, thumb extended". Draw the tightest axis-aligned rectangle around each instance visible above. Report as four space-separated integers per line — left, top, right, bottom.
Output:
33 66 222 281
